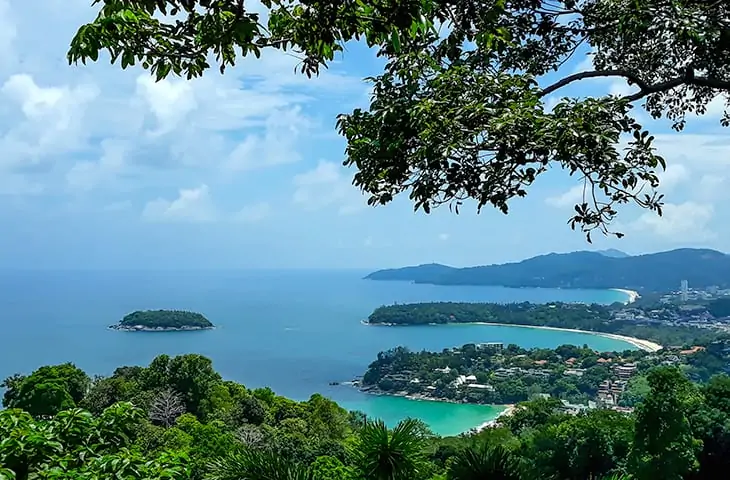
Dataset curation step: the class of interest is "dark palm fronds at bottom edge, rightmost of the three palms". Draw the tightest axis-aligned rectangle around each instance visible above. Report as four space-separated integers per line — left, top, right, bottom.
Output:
446 443 521 480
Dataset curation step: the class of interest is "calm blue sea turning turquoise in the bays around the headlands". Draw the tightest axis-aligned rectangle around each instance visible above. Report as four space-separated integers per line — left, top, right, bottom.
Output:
0 271 631 434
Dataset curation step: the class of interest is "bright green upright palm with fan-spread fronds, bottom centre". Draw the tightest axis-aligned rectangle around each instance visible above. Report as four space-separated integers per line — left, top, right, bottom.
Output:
351 419 424 480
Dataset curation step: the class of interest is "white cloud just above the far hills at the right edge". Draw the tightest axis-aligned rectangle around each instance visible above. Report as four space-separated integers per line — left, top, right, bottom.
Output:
629 201 716 243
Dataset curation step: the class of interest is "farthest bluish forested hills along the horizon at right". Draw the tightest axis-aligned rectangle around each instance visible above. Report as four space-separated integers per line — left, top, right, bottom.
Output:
365 248 730 292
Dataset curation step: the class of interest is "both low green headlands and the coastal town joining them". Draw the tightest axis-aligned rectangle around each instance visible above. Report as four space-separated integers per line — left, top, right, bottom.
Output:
354 284 730 415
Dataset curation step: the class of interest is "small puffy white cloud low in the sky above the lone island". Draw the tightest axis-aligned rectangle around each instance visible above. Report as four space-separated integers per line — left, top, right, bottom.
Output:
142 184 218 222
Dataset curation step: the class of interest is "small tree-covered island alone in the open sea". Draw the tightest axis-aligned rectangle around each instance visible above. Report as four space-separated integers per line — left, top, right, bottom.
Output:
109 310 214 332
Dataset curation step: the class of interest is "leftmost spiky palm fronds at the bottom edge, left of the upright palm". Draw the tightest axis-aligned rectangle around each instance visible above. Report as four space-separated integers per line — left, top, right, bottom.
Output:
206 448 312 480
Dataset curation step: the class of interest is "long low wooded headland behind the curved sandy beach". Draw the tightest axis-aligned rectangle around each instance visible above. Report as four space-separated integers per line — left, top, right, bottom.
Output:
367 302 724 345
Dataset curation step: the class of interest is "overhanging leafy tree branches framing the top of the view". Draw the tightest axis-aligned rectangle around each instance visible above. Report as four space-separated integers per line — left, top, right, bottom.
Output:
68 0 730 240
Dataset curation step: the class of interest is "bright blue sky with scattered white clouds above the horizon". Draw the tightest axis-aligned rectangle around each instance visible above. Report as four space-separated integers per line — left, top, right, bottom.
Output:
0 0 730 269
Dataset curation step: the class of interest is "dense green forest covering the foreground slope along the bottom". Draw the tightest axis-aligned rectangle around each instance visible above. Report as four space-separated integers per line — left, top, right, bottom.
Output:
0 355 730 480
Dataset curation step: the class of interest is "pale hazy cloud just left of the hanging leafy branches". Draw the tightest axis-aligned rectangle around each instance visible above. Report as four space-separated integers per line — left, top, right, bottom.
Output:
293 161 366 215
